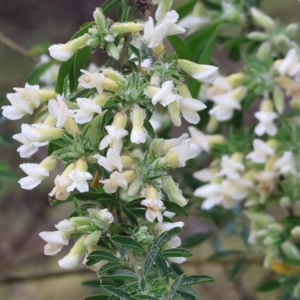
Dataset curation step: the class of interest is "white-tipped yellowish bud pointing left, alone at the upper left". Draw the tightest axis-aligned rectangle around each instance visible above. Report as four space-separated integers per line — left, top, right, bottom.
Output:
49 34 89 61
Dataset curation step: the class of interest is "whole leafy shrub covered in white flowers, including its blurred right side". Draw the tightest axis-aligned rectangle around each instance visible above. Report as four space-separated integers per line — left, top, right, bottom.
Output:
2 0 300 299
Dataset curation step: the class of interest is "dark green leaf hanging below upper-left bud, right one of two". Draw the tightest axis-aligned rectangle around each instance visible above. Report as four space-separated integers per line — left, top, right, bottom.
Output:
69 46 91 93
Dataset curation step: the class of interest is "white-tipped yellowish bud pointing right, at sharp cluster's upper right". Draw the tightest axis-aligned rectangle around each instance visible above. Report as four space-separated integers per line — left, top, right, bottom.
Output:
178 59 218 83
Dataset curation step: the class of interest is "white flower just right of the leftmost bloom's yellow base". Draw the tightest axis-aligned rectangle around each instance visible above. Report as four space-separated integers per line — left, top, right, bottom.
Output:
48 95 72 128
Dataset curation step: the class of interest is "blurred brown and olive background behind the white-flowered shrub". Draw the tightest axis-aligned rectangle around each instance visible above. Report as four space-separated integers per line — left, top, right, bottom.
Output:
0 0 300 300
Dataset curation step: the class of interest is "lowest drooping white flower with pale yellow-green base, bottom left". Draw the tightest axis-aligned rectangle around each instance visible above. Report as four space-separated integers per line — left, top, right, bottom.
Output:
58 235 86 269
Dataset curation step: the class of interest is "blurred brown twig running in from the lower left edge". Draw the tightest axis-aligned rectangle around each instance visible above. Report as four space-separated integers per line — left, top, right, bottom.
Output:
0 269 91 284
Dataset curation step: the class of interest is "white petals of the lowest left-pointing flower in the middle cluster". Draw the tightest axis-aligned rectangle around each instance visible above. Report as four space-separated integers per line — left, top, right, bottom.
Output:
18 163 49 190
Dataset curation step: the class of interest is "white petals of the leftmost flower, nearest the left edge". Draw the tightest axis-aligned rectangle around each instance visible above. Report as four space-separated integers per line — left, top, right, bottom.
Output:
2 83 40 120
